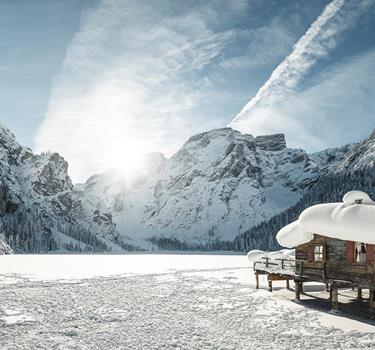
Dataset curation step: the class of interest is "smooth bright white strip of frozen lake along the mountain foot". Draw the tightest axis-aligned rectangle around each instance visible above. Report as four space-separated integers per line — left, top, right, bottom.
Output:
0 254 249 280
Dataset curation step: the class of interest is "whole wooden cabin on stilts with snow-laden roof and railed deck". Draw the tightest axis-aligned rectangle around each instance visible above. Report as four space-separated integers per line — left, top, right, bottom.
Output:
248 191 375 311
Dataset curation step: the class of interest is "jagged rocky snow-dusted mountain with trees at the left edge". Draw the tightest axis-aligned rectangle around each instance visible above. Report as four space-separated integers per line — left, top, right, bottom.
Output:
0 126 129 252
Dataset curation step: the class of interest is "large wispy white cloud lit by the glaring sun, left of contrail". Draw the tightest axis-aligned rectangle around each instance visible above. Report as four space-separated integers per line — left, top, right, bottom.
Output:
35 0 238 181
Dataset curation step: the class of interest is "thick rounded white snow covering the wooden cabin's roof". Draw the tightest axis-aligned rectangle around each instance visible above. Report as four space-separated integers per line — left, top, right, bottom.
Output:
276 191 375 248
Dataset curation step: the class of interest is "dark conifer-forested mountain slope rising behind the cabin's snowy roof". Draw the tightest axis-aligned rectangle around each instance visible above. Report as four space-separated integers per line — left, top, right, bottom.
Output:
234 131 375 251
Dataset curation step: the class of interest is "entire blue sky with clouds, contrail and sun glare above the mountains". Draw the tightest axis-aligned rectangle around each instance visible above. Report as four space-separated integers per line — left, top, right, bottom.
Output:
0 0 375 181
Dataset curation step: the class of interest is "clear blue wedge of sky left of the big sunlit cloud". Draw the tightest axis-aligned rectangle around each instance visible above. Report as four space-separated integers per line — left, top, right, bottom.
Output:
0 0 93 147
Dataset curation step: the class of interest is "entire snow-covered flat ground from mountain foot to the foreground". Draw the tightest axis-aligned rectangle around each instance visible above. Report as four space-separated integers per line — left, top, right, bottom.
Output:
0 254 375 349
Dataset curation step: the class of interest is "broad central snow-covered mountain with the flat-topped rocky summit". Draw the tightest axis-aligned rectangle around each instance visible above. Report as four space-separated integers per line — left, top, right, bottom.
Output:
79 128 348 248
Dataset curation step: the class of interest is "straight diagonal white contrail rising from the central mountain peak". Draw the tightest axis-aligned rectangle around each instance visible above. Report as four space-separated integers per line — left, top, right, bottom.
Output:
229 0 374 132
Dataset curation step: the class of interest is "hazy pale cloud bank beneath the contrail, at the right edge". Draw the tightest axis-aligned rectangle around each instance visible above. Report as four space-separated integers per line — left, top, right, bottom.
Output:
231 50 375 151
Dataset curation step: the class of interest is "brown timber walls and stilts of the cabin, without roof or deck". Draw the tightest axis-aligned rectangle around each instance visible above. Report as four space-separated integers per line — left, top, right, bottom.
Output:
294 234 375 309
